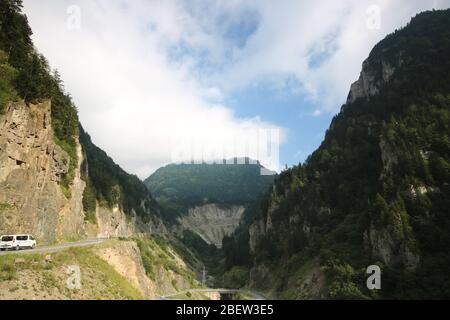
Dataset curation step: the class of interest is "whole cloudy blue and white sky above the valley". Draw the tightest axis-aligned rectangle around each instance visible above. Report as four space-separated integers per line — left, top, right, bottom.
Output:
23 0 450 179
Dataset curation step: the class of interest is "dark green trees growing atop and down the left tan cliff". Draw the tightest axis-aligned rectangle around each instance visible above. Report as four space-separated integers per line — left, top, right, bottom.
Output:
0 0 78 197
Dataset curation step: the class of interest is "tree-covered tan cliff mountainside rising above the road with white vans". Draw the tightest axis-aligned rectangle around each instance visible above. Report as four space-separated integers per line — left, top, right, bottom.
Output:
0 0 164 243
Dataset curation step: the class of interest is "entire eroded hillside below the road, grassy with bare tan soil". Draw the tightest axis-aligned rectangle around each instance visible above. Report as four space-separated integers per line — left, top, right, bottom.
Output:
0 237 206 300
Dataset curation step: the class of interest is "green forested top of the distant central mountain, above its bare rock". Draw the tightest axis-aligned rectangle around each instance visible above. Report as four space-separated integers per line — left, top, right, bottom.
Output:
144 159 274 217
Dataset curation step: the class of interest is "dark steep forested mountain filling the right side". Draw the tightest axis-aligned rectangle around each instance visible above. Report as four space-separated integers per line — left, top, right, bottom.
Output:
223 10 450 299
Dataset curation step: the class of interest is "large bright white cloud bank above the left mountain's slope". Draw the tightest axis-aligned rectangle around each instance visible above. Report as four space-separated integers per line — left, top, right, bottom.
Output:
21 1 283 178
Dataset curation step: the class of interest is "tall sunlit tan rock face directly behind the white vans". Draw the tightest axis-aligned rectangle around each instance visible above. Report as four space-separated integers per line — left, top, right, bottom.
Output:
0 101 85 242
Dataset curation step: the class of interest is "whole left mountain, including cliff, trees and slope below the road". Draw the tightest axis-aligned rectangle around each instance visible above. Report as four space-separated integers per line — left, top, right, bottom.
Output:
0 0 207 299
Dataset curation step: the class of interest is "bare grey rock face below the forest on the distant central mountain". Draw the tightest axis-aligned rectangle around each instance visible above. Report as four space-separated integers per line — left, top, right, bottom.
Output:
178 203 245 248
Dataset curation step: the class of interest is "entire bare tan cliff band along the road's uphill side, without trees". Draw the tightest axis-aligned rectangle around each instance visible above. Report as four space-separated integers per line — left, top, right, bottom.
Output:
0 100 165 243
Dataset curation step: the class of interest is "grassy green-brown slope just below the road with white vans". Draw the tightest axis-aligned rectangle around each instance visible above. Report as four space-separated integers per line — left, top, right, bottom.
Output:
0 242 145 299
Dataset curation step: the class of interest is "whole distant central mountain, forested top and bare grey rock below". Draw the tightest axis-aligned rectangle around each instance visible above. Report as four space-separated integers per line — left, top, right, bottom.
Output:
144 159 274 247
